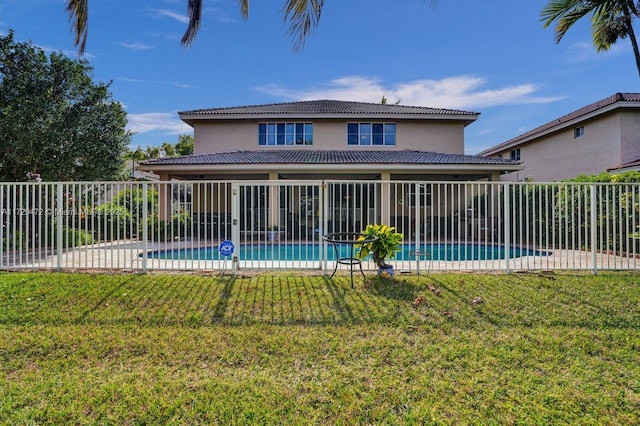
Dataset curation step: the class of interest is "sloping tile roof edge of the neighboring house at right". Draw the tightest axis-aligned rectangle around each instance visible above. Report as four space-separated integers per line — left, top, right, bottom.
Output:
478 93 640 155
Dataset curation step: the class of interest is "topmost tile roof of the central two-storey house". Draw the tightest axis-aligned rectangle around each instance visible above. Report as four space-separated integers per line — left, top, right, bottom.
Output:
179 99 479 117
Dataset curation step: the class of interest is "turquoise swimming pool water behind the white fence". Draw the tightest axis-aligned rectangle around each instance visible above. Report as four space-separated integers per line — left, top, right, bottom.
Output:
148 243 549 261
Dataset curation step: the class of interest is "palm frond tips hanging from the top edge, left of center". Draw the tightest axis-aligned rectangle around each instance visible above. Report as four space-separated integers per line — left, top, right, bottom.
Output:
66 0 437 55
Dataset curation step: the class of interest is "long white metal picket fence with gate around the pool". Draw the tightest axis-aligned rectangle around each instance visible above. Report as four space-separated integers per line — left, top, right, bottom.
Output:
0 181 640 272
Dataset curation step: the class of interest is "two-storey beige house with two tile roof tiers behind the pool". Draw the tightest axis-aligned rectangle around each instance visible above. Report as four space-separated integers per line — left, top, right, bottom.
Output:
140 100 522 236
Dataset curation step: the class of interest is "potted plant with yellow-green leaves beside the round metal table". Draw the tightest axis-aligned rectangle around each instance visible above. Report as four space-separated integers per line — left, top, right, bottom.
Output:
358 225 402 278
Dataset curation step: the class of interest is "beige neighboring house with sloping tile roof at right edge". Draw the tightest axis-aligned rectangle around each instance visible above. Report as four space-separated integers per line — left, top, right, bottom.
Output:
478 93 640 182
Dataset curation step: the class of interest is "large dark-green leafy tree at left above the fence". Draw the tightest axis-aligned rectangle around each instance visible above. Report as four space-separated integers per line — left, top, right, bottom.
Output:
0 31 130 181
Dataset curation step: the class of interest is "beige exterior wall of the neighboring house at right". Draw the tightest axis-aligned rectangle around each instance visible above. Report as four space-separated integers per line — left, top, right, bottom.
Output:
494 113 624 182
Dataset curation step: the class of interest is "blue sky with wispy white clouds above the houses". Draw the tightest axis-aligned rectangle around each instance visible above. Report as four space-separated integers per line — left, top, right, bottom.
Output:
0 0 640 154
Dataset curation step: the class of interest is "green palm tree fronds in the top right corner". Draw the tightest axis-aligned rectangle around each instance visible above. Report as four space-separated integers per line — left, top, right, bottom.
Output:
540 0 640 75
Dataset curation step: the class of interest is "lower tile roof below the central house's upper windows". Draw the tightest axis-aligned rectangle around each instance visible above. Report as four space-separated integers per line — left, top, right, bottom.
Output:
143 149 519 166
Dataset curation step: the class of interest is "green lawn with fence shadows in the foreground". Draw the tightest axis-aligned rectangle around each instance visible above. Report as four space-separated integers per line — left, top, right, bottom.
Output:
0 273 640 425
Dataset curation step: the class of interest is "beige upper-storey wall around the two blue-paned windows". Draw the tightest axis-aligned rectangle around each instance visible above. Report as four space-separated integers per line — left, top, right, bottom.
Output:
194 118 464 154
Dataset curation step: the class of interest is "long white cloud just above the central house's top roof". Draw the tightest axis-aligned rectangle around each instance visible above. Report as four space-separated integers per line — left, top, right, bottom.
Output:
256 75 562 109
